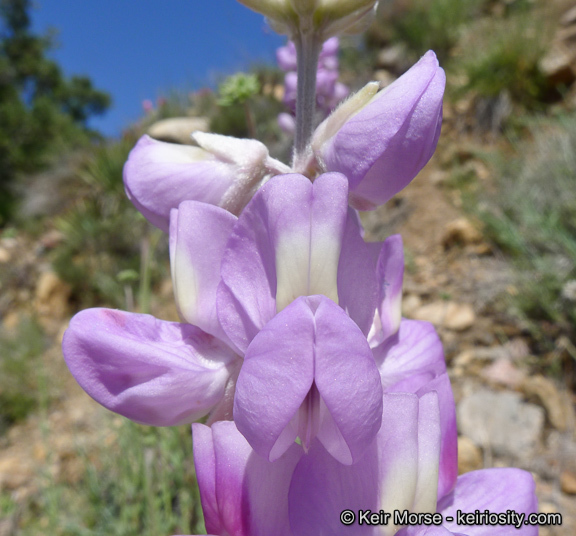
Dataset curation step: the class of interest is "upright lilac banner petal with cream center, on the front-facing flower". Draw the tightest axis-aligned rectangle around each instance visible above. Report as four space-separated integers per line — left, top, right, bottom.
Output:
217 173 378 351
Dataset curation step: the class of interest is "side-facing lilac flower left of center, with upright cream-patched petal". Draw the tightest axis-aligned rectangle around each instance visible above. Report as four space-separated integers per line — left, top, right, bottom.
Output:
62 201 242 426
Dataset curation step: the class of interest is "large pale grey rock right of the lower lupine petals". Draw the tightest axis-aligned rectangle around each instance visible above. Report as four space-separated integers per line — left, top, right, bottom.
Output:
457 389 544 457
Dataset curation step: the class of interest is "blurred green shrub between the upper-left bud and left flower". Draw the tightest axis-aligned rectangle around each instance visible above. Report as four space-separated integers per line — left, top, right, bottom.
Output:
52 139 166 307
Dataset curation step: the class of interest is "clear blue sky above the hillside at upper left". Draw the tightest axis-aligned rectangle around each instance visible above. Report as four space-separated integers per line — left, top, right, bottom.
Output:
32 0 285 135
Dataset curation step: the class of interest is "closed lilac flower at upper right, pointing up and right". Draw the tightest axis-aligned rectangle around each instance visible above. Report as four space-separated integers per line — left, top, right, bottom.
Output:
308 51 446 210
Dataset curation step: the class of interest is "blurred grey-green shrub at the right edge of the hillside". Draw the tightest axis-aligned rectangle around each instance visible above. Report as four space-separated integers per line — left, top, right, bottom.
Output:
478 115 576 344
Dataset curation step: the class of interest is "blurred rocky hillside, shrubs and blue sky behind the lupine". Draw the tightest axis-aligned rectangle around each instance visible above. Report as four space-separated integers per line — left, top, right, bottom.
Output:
0 0 576 536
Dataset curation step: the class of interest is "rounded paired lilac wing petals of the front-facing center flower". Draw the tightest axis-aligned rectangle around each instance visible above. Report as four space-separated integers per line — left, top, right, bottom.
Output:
234 296 382 465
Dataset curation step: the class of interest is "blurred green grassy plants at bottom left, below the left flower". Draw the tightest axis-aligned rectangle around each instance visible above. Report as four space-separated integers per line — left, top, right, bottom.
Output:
17 415 204 536
